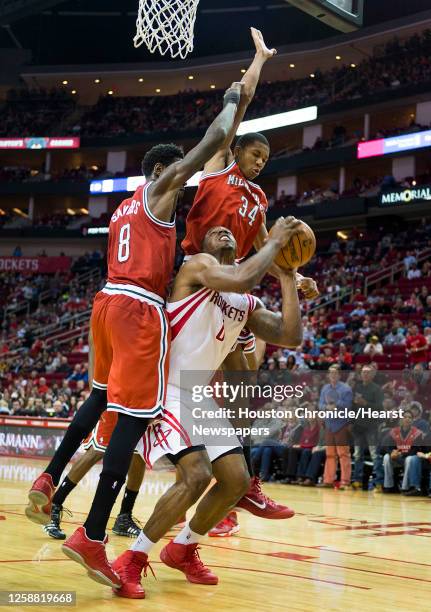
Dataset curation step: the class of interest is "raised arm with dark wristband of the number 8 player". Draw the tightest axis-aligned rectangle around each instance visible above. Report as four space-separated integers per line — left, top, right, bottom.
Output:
149 83 242 210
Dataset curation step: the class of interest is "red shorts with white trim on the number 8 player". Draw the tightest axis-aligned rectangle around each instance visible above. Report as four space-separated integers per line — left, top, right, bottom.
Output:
91 284 170 418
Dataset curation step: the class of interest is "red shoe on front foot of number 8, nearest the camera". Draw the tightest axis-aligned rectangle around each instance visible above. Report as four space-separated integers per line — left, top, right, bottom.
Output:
61 527 121 588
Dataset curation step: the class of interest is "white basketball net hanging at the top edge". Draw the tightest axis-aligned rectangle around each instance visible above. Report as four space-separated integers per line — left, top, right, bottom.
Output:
133 0 199 59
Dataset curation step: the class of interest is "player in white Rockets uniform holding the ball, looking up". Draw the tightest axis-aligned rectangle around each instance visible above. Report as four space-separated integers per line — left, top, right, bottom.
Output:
113 217 302 599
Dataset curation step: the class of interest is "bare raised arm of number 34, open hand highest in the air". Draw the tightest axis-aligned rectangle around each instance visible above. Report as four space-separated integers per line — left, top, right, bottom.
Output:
204 28 277 174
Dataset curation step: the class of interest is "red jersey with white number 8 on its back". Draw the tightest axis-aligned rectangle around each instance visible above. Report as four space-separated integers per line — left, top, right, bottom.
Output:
108 183 176 299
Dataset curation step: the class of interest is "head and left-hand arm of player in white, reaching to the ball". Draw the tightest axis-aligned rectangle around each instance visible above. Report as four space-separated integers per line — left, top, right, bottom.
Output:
175 217 300 293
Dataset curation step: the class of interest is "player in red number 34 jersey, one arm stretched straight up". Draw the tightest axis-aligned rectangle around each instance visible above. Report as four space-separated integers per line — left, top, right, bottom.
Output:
181 28 318 536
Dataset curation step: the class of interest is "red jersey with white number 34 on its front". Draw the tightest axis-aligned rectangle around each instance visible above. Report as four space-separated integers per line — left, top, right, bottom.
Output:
181 162 268 259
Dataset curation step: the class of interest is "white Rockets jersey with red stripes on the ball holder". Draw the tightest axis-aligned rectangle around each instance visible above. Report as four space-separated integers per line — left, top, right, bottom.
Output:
166 287 259 387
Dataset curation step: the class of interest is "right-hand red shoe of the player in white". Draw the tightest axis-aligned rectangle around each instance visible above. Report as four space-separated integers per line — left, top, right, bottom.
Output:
160 540 218 584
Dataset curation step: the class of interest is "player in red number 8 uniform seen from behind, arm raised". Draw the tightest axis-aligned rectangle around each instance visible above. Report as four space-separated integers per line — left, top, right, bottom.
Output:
29 83 241 587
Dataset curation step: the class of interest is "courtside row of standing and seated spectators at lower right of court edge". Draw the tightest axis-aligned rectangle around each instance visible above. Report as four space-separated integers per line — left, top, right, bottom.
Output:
252 358 431 497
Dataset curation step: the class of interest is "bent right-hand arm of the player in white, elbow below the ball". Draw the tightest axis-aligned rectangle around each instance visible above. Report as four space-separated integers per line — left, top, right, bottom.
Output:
247 270 302 348
